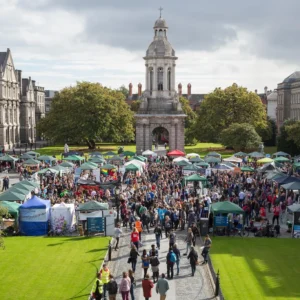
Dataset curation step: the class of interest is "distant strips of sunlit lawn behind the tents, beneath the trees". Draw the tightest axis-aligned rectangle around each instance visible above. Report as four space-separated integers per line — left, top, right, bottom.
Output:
36 143 277 159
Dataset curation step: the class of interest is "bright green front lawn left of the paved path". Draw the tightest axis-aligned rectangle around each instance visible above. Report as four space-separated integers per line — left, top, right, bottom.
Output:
0 237 109 300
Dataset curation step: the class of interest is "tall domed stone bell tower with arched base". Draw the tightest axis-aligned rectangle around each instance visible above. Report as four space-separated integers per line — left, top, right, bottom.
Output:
135 17 186 153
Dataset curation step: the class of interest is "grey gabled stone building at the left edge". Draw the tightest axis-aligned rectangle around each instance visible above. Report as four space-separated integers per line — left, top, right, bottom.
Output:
0 49 45 150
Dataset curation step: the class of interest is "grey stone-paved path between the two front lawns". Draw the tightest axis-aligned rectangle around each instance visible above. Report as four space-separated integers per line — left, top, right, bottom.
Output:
105 229 214 300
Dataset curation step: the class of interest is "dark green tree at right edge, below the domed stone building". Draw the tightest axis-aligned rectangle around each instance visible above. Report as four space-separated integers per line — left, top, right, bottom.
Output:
277 120 300 155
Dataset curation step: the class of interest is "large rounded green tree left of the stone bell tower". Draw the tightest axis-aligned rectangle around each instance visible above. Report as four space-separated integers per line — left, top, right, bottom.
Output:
37 82 134 149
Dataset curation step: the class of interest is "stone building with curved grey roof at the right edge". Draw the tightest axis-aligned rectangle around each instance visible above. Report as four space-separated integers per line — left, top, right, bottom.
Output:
277 72 300 129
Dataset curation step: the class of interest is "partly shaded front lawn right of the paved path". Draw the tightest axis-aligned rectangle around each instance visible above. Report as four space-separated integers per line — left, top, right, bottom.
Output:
211 237 300 300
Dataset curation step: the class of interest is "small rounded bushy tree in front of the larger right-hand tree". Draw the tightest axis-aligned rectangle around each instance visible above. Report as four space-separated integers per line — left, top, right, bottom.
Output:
221 123 261 151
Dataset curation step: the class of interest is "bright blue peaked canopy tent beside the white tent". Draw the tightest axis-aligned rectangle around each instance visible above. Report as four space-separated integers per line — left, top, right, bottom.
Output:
19 196 51 236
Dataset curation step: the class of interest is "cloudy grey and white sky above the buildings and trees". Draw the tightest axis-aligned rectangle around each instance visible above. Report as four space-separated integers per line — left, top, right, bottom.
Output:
0 0 300 93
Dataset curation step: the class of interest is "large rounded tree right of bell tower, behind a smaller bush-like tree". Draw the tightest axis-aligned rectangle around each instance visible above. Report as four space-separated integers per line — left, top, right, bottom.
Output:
195 84 267 142
